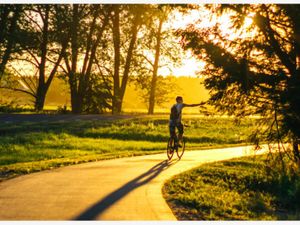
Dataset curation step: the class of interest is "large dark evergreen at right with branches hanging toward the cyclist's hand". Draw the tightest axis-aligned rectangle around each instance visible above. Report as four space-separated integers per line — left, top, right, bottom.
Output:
178 4 300 163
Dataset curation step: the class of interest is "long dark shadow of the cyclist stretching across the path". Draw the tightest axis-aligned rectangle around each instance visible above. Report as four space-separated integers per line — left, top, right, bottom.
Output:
74 160 177 220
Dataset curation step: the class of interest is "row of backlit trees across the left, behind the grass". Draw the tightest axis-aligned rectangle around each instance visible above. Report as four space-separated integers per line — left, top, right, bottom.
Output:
0 4 186 114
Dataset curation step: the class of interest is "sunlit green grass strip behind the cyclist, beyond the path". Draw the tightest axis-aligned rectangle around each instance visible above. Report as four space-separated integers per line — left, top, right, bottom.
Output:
0 116 255 179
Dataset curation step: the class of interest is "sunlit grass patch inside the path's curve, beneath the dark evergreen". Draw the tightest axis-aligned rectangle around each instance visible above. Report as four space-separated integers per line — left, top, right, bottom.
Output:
163 156 300 220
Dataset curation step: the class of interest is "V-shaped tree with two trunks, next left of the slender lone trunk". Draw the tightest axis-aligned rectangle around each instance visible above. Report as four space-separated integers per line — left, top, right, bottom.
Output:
112 5 146 114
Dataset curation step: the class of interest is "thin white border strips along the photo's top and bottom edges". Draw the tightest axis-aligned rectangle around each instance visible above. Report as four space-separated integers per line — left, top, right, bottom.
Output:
0 0 300 225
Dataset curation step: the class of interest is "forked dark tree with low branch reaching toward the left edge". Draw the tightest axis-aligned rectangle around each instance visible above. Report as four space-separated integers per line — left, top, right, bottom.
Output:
1 5 67 111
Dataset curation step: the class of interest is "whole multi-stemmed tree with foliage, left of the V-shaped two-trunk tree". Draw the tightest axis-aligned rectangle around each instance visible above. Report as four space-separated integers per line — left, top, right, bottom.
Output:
63 4 111 113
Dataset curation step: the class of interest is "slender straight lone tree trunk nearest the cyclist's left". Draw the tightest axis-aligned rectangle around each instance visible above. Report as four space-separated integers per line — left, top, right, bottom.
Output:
148 18 163 114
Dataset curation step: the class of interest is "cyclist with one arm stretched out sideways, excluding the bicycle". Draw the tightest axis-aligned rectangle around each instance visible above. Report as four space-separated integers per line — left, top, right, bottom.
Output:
169 96 202 147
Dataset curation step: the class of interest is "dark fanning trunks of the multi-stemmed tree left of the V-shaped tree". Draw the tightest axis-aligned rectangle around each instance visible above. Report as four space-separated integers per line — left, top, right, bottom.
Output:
64 4 110 114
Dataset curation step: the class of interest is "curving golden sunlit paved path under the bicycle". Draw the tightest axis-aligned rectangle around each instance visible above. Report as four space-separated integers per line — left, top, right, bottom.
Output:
0 147 264 220
